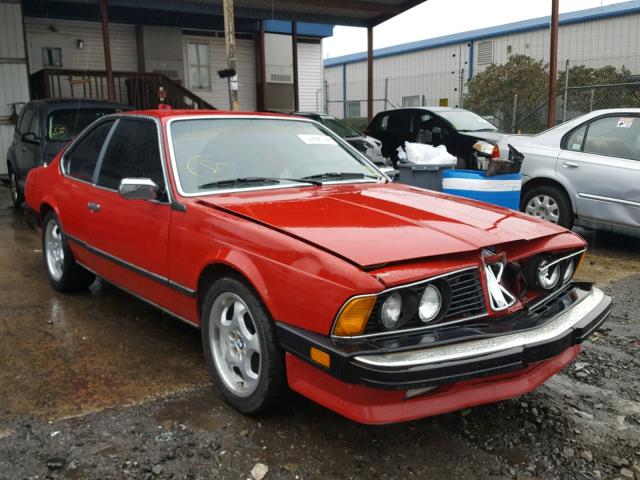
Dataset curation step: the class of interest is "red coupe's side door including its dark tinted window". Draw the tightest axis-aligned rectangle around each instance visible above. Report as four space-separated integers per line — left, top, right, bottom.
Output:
86 117 170 304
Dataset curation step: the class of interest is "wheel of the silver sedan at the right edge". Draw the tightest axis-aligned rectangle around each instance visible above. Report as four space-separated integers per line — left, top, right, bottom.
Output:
522 185 573 229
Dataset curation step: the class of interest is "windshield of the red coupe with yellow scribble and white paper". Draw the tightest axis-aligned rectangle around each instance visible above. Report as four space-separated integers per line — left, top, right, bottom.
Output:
170 118 381 195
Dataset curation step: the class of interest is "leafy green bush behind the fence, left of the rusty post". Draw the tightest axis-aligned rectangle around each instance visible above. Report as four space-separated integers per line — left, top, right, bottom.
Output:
465 55 549 131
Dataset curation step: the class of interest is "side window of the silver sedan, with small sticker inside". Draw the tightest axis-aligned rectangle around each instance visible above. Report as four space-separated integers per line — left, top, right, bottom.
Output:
583 116 640 160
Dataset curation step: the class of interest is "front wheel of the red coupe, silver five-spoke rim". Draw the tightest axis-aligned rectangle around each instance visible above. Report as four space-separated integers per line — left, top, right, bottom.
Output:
202 277 286 414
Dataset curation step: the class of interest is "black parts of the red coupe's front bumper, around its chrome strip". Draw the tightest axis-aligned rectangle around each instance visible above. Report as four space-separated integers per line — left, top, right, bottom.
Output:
276 284 613 390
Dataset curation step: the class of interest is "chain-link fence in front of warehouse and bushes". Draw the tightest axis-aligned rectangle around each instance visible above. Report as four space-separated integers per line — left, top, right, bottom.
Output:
323 51 640 133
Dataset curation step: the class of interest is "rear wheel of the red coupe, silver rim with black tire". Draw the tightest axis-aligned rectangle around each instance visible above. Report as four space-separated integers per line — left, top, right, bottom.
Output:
42 212 95 292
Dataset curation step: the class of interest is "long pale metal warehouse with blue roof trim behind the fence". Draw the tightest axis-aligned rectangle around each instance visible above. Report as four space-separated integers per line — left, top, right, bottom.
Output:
324 0 640 117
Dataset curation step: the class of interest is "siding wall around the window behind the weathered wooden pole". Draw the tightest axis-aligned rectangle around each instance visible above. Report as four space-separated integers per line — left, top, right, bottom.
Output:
182 35 256 110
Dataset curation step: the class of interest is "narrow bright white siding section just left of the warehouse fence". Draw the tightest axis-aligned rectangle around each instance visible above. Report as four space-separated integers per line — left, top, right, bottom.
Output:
298 42 324 112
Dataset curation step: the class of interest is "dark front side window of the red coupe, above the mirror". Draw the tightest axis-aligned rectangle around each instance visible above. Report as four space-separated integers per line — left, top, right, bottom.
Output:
98 118 164 191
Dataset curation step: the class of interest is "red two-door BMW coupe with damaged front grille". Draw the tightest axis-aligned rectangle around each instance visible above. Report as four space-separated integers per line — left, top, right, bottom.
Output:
26 110 611 424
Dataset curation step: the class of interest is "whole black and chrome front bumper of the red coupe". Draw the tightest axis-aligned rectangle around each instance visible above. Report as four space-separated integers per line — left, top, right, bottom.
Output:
277 283 612 391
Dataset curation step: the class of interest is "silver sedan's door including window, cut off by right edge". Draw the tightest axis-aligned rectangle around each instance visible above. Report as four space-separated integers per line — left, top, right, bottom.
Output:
556 114 640 229
